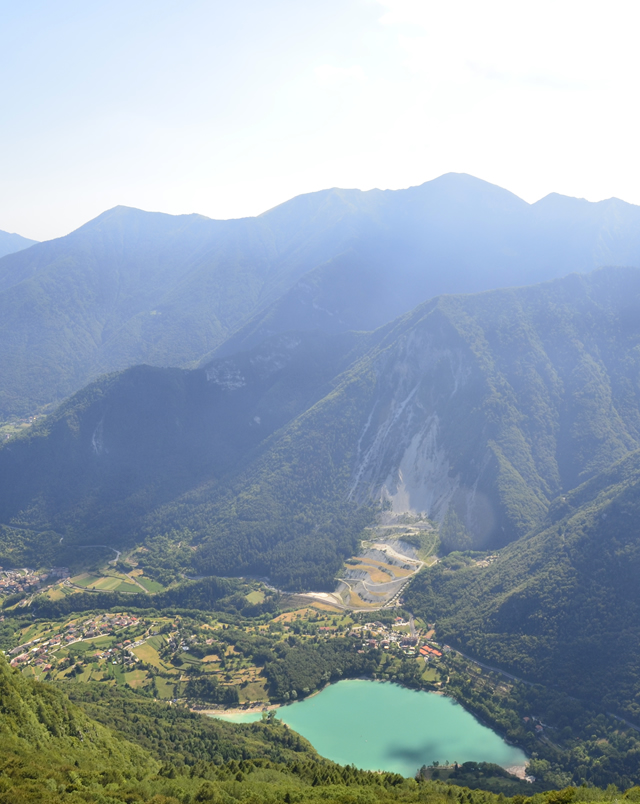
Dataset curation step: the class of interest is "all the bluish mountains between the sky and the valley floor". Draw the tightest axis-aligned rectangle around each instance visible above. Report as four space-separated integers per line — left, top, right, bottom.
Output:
0 175 640 722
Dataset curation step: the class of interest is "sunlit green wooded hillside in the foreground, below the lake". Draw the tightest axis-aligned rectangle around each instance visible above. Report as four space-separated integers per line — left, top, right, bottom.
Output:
0 655 588 804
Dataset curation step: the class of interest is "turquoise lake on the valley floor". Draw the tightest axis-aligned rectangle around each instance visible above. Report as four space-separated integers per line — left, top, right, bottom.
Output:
212 679 527 776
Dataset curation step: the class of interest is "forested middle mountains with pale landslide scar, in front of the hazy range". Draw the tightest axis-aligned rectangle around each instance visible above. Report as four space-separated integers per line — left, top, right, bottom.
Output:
0 269 640 588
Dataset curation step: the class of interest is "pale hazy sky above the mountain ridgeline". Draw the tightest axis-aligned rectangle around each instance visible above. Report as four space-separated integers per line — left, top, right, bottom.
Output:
0 0 640 239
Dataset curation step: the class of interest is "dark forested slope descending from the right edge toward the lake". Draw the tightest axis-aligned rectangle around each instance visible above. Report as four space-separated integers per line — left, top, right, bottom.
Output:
407 451 640 724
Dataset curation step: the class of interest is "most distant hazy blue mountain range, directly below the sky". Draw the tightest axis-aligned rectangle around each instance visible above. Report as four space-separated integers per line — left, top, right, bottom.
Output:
0 174 640 419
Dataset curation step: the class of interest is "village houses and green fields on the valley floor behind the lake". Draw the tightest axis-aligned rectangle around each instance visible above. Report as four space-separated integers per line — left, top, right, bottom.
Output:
1 592 449 705
